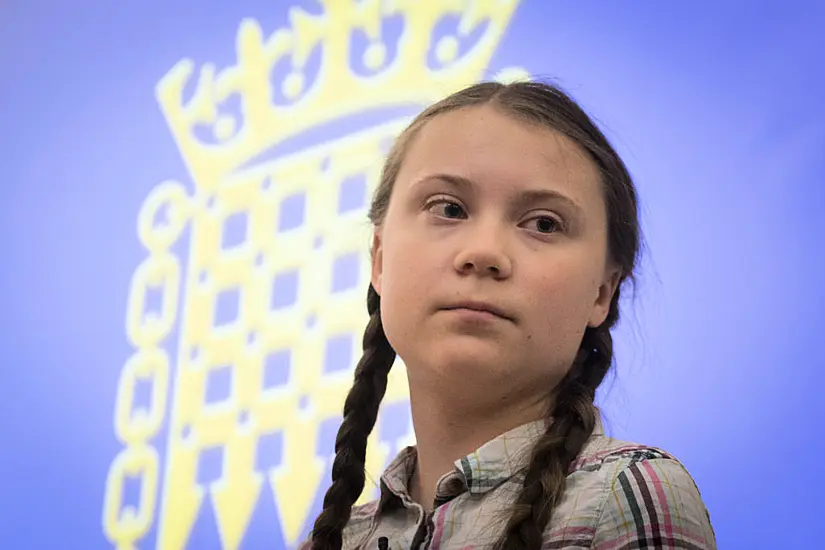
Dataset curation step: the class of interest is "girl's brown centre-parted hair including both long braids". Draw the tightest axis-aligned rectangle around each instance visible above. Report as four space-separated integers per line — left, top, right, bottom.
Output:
312 82 640 550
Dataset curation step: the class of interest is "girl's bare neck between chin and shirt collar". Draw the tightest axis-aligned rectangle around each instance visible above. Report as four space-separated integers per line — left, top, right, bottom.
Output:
410 388 548 511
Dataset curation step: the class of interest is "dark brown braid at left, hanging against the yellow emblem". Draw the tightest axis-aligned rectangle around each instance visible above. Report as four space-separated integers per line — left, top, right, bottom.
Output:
312 285 395 550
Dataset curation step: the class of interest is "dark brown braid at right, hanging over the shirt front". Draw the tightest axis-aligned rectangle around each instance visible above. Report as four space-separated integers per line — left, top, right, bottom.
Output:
496 289 619 550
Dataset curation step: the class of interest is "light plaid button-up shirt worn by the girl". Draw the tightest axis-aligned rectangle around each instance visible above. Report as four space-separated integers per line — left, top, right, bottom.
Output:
302 414 716 550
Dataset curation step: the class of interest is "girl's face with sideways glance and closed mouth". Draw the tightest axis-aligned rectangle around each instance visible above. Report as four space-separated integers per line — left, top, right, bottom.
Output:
372 105 618 412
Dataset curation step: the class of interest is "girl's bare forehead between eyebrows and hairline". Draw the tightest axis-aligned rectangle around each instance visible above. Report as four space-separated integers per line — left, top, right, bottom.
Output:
396 105 603 209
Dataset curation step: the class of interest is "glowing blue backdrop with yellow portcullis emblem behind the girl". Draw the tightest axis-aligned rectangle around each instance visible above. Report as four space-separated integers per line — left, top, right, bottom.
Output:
0 0 825 550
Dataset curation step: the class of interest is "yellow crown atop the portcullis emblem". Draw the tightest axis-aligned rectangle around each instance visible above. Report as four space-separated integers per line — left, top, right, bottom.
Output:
157 0 518 190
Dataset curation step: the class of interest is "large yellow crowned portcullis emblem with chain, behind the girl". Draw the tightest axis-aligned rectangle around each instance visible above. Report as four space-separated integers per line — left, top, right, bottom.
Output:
129 0 523 550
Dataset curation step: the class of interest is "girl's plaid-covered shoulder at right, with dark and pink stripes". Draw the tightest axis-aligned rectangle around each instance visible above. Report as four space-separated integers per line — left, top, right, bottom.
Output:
571 436 716 550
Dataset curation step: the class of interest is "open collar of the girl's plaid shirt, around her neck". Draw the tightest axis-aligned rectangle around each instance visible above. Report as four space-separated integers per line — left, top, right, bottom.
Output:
379 408 604 509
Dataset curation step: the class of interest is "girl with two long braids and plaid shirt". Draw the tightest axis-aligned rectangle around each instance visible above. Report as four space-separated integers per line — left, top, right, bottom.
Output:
303 82 716 550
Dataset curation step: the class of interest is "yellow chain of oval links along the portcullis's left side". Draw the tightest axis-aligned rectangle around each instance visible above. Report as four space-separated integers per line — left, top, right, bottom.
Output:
103 181 189 550
